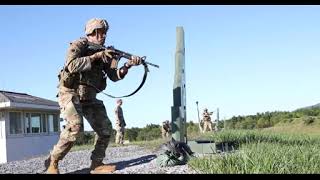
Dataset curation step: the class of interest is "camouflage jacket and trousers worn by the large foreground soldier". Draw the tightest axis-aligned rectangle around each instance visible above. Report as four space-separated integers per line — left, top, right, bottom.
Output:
51 35 121 161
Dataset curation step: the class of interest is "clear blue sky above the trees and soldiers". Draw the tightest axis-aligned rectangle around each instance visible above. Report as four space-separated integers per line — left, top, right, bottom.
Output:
0 5 320 130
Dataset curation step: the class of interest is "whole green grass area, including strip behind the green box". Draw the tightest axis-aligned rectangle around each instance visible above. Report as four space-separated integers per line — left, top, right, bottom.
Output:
189 130 320 174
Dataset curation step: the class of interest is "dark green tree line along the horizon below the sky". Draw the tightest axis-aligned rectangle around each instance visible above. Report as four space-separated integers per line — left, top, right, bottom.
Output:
76 107 320 145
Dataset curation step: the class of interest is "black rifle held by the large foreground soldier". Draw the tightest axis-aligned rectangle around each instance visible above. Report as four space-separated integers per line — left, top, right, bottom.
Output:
88 42 159 71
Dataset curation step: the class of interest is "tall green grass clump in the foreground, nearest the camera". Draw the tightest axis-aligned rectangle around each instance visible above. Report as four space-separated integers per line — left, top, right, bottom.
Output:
189 142 320 174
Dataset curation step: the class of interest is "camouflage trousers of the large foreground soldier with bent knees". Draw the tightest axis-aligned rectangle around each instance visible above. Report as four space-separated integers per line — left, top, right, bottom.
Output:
50 92 112 162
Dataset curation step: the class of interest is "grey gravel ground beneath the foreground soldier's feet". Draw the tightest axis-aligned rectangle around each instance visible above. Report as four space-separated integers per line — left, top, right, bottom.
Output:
0 146 196 174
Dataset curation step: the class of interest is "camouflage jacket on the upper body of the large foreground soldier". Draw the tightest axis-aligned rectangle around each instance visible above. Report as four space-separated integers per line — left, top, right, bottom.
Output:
59 38 121 100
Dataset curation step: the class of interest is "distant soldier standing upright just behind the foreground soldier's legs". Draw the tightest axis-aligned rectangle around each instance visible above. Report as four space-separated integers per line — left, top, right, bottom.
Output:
114 99 126 144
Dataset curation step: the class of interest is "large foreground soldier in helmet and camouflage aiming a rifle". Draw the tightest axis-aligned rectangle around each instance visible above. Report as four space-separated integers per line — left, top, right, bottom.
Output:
45 18 141 174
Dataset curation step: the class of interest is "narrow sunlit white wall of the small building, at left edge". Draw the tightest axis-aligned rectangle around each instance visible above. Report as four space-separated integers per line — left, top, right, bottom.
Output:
0 111 7 164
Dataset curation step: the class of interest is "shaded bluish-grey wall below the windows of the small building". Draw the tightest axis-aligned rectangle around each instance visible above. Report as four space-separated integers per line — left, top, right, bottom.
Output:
6 133 59 162
